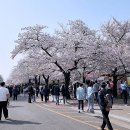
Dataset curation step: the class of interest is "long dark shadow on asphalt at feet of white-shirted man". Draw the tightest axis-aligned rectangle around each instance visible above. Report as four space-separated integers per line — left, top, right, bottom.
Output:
0 119 42 125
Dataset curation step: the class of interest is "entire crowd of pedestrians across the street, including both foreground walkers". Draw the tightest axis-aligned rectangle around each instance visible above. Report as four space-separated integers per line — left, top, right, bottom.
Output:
0 79 129 130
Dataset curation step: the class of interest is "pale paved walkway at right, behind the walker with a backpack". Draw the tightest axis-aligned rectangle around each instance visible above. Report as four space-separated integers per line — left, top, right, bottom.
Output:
63 99 130 129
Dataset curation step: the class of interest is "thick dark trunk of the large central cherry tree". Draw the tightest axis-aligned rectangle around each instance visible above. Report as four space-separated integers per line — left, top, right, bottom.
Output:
64 72 70 99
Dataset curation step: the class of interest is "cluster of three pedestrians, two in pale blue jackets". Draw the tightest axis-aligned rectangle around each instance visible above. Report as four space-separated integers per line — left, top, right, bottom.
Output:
76 80 99 113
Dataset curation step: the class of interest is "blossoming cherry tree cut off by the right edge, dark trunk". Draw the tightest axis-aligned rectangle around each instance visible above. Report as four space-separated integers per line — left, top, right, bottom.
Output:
101 18 130 96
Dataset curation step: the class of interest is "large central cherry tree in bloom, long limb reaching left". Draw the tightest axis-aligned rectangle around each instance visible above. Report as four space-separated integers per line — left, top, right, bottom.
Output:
12 20 98 98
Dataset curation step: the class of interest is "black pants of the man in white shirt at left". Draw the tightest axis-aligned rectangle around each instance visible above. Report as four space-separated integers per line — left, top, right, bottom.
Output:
0 101 8 120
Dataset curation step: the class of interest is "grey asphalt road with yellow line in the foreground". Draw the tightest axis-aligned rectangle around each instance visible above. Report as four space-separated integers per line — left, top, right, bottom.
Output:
0 96 127 130
